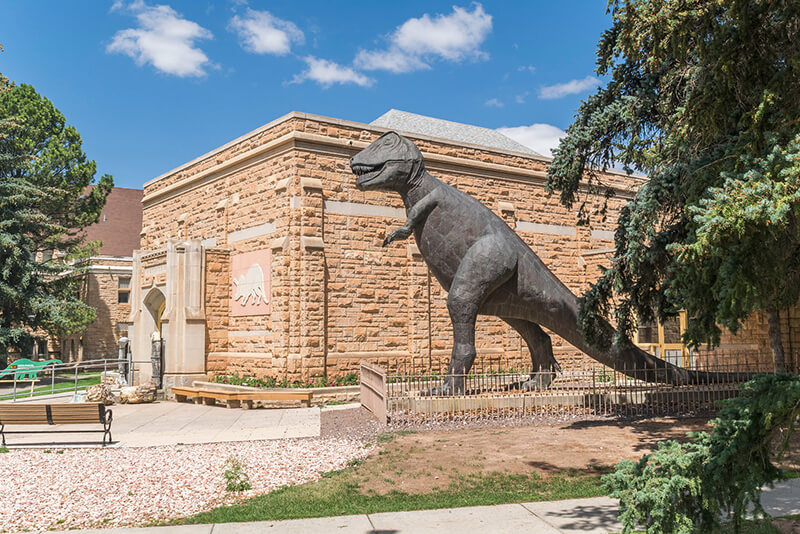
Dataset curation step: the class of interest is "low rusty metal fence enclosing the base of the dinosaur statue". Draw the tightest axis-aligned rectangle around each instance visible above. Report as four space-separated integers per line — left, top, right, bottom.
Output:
361 353 792 425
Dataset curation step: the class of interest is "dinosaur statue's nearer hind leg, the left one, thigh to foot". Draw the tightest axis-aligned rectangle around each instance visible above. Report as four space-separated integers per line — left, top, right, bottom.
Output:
430 235 517 395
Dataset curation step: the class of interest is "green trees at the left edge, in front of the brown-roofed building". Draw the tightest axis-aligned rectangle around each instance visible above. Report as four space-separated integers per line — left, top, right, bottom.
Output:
0 72 113 359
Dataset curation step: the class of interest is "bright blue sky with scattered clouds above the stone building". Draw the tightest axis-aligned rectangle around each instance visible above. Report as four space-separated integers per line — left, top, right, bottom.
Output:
0 0 610 191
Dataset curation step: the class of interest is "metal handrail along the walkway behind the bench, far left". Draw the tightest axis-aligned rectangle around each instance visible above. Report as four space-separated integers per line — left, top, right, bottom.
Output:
0 359 130 402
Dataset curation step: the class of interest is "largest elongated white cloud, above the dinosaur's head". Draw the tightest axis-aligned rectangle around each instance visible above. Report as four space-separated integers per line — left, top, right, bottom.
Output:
355 4 492 73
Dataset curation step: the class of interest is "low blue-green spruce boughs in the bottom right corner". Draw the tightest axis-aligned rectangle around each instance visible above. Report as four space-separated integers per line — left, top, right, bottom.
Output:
603 375 800 534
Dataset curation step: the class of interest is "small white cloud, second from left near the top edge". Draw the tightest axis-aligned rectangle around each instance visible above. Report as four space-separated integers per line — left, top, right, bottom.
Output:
233 8 305 56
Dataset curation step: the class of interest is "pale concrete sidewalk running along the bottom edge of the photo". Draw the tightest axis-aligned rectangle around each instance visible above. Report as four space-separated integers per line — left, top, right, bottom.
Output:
56 479 800 534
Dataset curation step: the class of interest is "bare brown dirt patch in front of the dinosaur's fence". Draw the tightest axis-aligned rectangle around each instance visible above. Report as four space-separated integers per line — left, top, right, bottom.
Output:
357 418 709 494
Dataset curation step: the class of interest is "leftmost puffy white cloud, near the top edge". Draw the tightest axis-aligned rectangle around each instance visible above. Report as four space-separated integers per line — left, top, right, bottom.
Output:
111 0 214 77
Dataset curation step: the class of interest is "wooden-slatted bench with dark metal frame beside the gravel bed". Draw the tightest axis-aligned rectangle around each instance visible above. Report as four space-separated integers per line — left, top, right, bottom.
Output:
0 402 112 447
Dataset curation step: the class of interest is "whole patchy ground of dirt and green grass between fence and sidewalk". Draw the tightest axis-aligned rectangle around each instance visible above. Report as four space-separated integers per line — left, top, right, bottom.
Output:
170 420 797 534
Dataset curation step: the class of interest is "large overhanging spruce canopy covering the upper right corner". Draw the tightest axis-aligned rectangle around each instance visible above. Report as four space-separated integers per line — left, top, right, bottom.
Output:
548 0 800 364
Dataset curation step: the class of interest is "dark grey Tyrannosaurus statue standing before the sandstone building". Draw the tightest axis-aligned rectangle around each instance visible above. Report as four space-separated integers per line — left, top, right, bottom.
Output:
350 132 720 394
